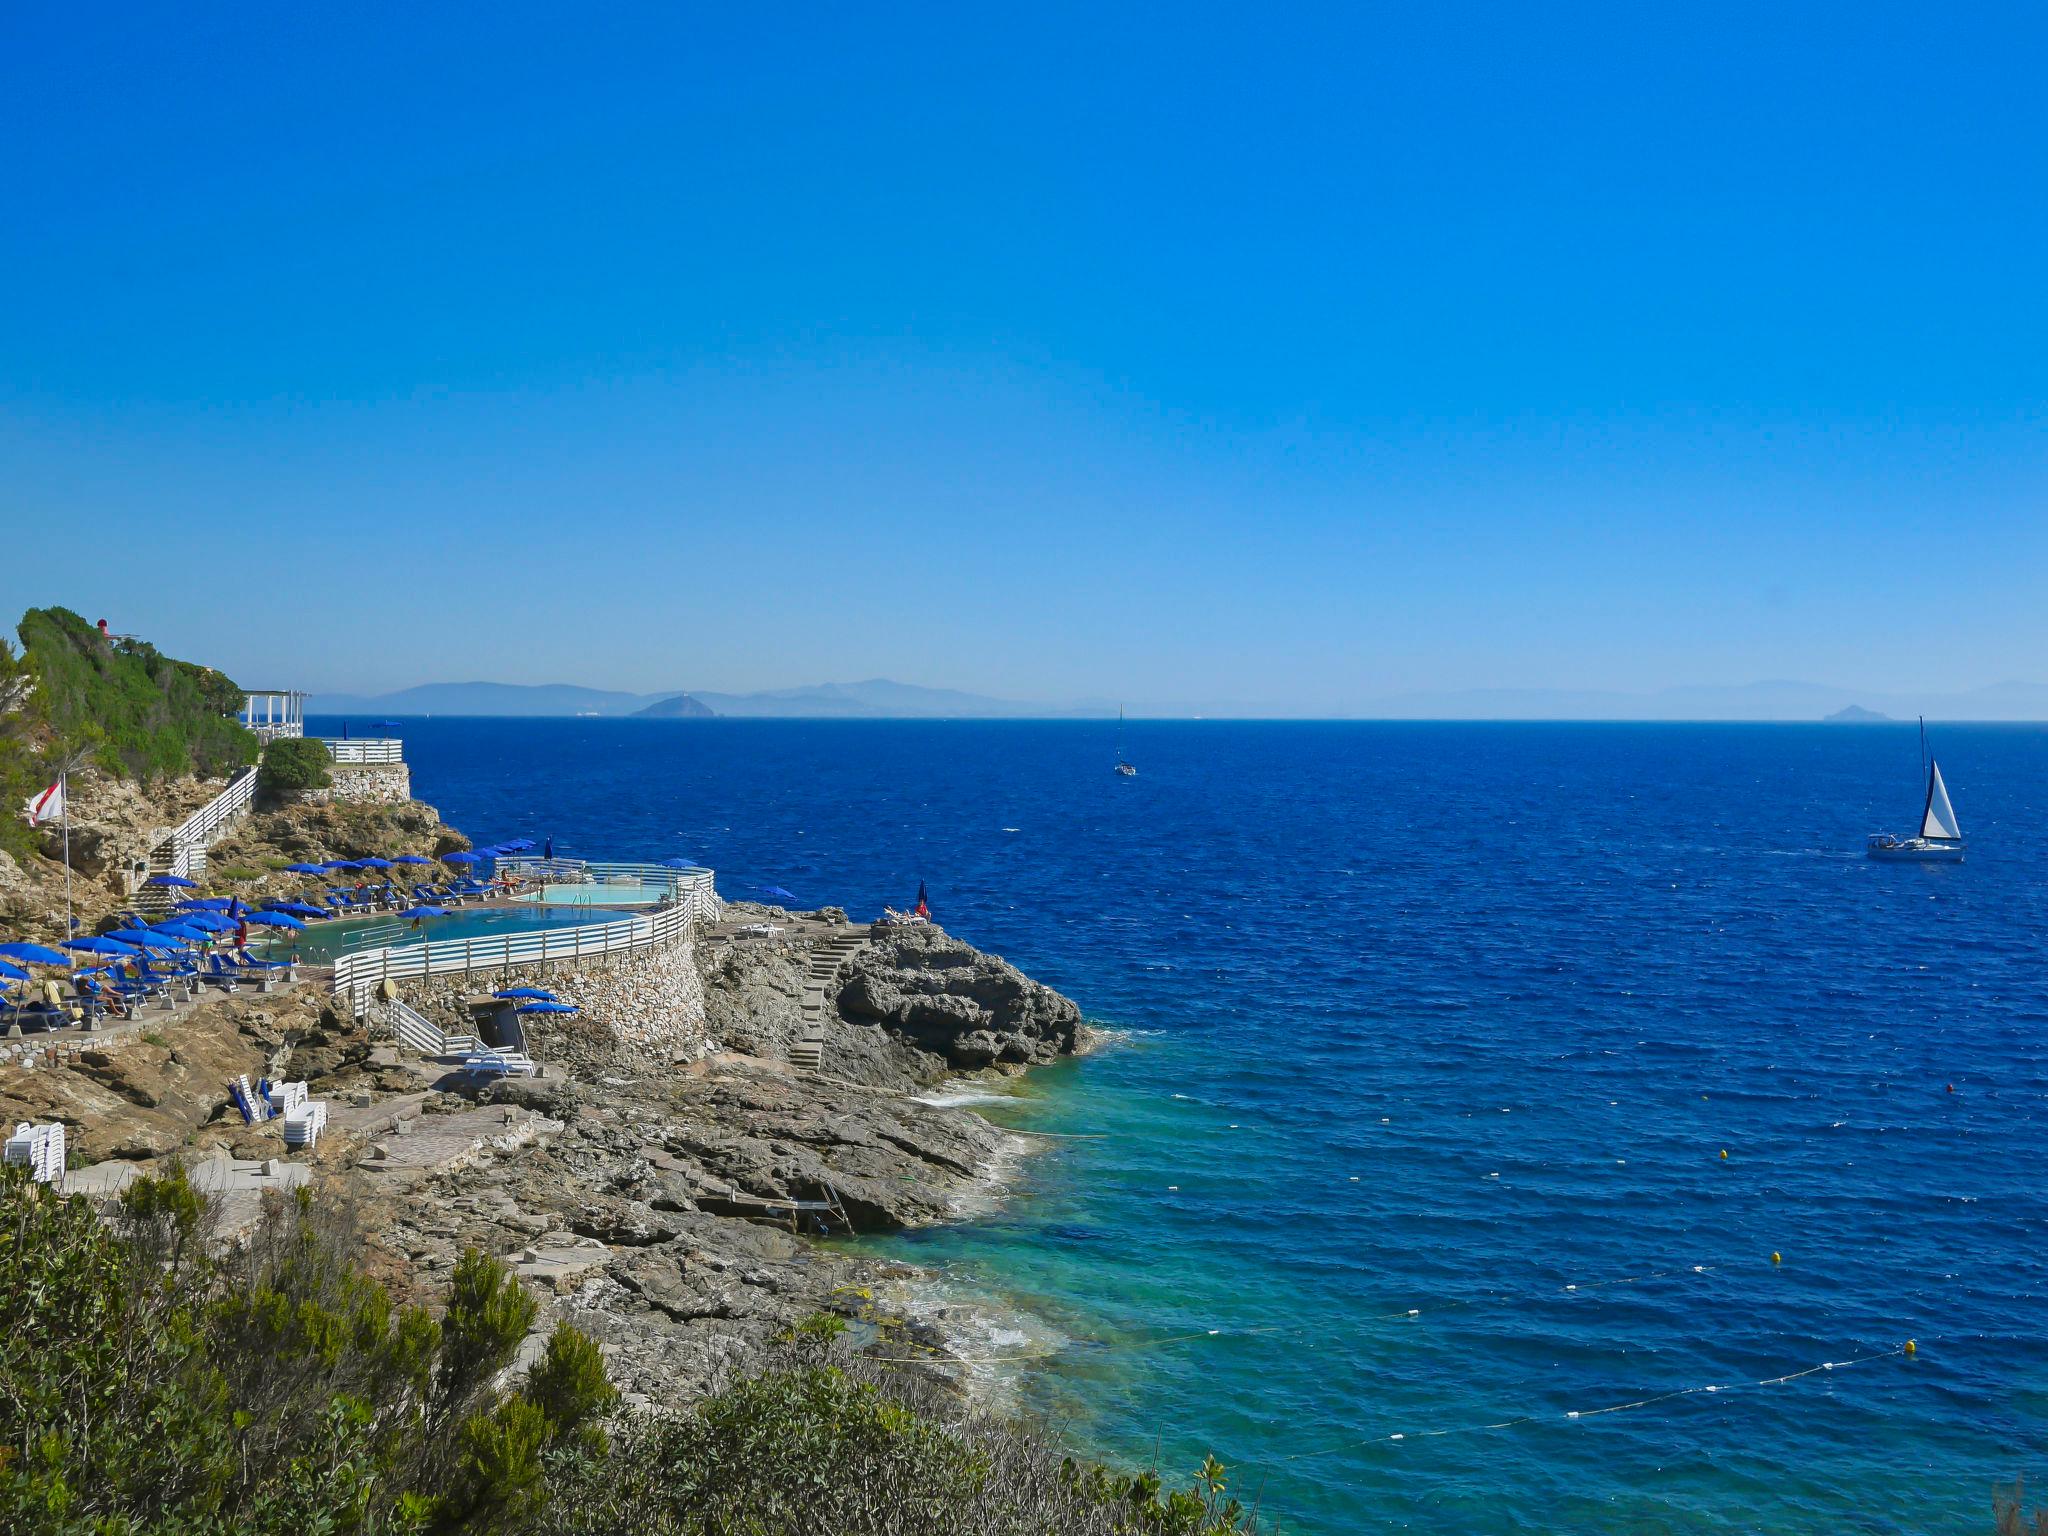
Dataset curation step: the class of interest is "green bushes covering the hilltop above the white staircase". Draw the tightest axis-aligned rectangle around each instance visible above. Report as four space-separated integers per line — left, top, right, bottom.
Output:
0 608 256 852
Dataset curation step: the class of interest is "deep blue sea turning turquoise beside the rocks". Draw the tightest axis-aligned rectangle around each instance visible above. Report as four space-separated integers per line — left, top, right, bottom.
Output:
311 721 2048 1532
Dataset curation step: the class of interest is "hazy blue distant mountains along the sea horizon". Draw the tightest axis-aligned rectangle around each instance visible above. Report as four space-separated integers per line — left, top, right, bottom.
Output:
307 678 2048 721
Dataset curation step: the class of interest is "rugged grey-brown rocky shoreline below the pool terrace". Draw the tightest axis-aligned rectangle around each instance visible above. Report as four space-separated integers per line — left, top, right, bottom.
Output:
0 884 1087 1403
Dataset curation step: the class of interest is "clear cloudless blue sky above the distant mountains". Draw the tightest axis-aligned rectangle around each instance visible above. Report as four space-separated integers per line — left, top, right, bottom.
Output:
0 4 2048 713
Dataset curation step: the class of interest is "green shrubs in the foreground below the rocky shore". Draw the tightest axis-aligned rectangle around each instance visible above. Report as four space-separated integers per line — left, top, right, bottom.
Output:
0 1169 1251 1536
